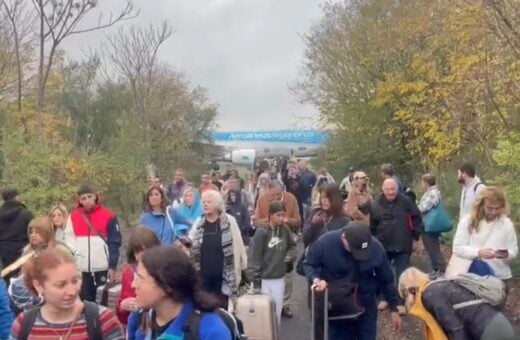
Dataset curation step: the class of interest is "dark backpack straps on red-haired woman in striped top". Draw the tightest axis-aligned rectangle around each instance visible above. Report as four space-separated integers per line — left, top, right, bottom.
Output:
18 301 103 340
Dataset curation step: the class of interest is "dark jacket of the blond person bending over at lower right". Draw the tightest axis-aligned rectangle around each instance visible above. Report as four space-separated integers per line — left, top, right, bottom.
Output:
422 281 499 340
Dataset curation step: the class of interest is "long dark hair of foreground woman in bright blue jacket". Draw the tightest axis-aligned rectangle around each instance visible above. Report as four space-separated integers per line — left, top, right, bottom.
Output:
141 246 219 312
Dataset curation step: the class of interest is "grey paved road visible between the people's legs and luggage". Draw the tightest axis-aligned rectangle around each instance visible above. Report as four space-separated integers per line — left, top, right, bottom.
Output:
280 246 428 340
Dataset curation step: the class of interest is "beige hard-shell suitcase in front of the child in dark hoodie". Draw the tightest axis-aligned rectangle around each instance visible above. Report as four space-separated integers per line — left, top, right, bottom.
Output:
235 294 278 340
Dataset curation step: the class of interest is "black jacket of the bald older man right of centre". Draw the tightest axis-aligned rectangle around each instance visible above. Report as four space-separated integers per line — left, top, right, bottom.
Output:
370 194 423 252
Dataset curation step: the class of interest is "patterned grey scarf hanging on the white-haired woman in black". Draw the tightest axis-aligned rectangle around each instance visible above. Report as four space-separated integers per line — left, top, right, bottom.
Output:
190 213 238 296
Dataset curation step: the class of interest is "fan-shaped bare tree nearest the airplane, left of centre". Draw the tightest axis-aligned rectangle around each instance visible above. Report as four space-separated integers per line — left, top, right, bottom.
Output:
103 21 173 149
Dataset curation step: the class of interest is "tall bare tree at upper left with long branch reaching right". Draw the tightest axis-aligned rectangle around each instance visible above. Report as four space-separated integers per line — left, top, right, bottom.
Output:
32 0 139 110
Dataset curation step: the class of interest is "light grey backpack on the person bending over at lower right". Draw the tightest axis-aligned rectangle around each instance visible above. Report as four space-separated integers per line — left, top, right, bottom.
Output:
452 273 506 309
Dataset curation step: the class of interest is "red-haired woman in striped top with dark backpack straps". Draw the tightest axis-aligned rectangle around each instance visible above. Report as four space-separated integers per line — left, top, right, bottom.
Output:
9 248 125 340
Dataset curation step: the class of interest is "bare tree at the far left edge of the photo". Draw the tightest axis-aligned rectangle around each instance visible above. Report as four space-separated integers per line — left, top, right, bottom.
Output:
0 0 33 111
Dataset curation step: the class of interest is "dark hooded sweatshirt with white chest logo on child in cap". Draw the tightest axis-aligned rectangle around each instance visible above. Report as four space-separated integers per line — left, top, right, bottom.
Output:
247 225 296 282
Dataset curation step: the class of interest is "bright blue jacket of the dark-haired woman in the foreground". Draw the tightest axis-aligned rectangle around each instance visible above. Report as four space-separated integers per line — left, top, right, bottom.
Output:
128 301 231 340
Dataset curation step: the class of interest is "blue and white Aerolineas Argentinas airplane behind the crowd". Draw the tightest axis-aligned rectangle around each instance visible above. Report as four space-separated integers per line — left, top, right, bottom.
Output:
213 130 326 165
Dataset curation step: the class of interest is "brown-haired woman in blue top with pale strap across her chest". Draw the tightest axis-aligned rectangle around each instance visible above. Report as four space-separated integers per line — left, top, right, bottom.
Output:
139 187 192 246
